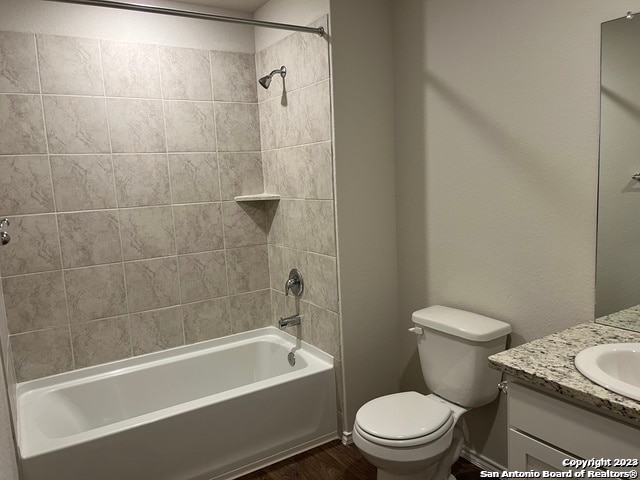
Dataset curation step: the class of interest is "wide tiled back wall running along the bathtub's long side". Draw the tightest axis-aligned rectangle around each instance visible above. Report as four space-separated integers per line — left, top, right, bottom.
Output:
0 32 272 381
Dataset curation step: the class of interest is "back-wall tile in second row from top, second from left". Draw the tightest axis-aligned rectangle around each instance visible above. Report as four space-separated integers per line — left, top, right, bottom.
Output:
42 96 111 154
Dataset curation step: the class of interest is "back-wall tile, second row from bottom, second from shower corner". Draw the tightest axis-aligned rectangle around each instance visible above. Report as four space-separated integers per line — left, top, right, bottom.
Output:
178 250 229 303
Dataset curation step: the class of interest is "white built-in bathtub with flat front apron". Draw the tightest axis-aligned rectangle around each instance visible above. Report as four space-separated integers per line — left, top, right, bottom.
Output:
17 327 337 480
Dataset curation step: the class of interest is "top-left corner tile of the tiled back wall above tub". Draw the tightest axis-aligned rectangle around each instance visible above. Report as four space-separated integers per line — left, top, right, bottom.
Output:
0 32 40 93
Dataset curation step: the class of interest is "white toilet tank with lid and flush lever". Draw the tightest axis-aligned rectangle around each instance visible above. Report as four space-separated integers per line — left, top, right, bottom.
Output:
411 305 511 408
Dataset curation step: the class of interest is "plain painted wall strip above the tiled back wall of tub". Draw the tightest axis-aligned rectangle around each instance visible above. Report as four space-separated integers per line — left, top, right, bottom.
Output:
0 0 254 53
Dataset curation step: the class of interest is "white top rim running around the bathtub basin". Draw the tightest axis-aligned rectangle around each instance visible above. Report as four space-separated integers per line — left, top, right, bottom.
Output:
16 326 334 460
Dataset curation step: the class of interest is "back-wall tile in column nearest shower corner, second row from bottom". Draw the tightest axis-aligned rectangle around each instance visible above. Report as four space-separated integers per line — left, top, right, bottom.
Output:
226 245 269 295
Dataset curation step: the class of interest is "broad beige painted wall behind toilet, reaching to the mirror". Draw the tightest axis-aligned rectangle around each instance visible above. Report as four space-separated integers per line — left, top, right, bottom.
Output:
392 0 640 465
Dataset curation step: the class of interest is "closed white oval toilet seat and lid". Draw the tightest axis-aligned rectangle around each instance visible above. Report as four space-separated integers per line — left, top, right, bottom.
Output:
355 392 454 447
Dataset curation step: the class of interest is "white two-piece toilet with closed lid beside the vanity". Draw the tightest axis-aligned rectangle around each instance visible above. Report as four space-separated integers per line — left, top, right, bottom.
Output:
353 305 511 480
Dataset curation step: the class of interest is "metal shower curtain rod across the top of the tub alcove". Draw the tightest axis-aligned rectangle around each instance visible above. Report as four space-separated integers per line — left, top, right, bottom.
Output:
41 0 325 37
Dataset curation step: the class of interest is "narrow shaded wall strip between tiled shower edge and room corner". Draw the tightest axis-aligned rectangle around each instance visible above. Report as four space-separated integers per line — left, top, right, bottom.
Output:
331 0 399 436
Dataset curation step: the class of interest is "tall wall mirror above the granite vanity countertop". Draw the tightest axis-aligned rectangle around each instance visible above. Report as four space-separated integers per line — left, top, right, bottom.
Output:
595 14 640 331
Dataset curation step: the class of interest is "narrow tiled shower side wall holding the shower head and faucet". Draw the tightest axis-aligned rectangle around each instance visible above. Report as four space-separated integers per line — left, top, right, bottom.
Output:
256 17 342 416
